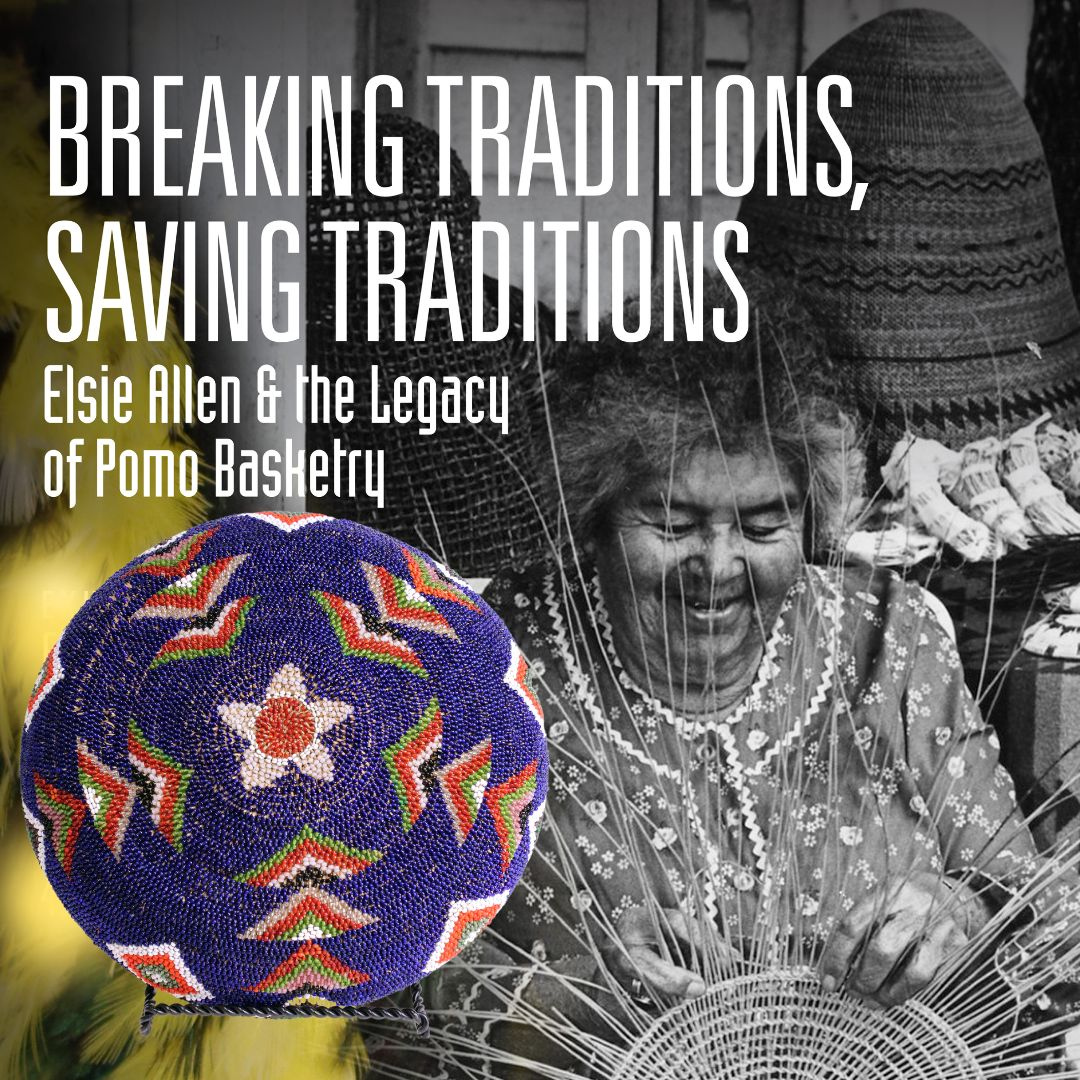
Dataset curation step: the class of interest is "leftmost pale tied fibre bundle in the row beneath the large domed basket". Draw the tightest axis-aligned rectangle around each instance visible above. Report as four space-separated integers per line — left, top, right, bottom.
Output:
881 432 1004 561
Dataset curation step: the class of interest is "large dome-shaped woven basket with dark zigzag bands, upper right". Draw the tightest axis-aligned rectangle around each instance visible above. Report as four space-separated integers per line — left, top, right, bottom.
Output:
739 8 1080 463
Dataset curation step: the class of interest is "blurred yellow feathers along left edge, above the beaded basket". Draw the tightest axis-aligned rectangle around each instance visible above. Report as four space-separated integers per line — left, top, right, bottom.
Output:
0 50 206 786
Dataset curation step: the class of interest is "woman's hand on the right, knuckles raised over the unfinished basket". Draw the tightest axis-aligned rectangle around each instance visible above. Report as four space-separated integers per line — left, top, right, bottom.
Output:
821 873 988 1007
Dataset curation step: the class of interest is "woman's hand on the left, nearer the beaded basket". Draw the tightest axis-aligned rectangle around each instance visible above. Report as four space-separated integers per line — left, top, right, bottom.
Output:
605 907 731 998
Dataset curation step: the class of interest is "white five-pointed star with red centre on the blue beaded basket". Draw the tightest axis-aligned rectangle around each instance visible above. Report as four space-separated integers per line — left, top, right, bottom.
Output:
217 664 352 789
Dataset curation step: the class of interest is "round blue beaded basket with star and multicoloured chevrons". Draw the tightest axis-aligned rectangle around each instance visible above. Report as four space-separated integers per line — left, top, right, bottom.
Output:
22 512 548 1009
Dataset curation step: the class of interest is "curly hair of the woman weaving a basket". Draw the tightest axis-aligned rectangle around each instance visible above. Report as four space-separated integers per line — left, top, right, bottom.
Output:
553 270 863 555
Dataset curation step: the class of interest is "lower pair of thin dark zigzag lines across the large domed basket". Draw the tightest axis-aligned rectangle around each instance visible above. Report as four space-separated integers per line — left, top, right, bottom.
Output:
755 248 1066 296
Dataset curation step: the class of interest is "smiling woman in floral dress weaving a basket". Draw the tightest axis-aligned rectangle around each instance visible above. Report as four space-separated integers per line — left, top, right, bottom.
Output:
375 281 1068 1077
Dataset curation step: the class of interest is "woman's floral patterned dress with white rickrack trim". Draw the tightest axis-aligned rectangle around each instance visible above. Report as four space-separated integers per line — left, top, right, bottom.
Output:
382 567 1080 1076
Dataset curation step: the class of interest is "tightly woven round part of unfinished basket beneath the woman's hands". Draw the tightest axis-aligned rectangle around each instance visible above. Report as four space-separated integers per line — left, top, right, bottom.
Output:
616 972 985 1080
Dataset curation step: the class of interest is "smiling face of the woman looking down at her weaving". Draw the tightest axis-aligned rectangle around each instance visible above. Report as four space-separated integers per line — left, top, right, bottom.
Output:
596 449 804 712
